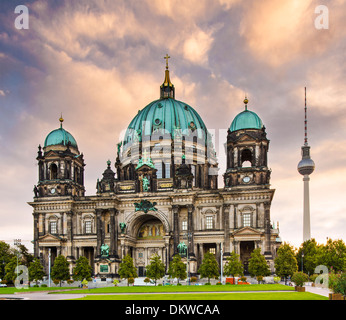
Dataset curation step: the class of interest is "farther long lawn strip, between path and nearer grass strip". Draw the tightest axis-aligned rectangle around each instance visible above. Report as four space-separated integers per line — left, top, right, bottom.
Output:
56 284 294 294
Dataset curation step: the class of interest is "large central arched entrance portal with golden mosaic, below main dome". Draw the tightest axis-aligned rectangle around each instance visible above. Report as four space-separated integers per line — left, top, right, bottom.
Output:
128 213 169 277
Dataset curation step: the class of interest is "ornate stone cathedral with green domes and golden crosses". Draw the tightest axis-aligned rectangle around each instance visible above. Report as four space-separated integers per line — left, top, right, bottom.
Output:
29 56 281 278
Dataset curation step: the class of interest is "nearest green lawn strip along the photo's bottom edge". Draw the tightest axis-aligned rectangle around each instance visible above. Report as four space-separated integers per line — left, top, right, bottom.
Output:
76 292 328 301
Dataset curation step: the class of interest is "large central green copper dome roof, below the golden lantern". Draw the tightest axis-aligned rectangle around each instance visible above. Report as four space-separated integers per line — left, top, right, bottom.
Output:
124 98 208 148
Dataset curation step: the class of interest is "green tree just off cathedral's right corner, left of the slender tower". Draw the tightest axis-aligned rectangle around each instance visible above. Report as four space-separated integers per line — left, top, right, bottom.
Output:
274 242 298 283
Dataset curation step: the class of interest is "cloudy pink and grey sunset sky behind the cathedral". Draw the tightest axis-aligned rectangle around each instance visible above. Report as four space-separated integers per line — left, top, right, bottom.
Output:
0 0 346 247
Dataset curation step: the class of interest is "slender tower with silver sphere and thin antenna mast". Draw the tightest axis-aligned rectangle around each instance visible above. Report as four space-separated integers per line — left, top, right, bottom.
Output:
298 87 315 242
